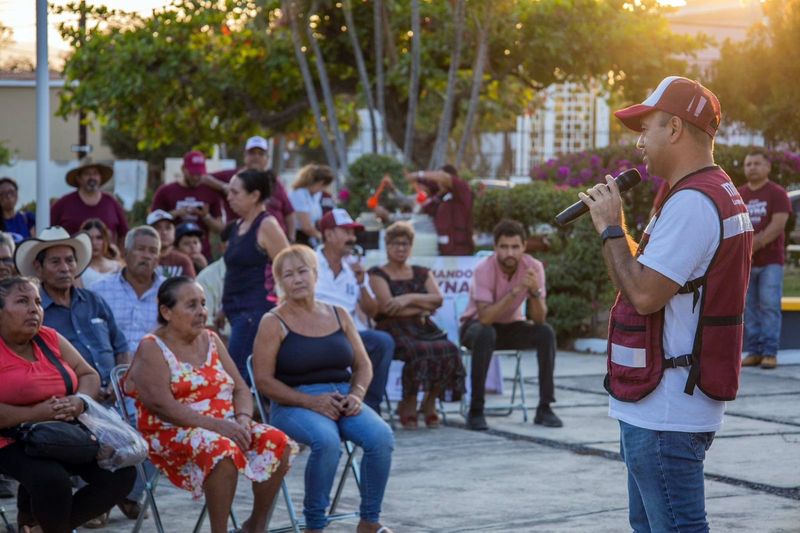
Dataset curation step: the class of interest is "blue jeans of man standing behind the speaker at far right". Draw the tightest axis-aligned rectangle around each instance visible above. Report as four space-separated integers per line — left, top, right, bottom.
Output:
744 265 783 355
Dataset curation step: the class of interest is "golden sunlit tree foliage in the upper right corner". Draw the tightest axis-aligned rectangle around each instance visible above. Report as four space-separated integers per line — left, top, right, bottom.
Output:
710 0 800 149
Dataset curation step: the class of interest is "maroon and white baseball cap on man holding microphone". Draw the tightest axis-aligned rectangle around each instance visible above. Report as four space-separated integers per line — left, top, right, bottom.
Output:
614 76 722 137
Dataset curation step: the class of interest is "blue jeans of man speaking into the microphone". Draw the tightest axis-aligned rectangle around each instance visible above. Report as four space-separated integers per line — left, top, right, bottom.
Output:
619 420 714 533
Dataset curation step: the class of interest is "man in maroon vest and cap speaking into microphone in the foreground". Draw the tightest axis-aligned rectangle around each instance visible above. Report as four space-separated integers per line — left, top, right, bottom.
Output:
580 76 753 532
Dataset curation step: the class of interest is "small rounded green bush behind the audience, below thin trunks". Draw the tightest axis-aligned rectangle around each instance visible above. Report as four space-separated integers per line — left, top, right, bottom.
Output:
340 154 405 217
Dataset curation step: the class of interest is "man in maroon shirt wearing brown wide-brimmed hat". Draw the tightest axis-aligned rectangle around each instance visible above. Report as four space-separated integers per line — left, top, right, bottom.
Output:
50 157 128 249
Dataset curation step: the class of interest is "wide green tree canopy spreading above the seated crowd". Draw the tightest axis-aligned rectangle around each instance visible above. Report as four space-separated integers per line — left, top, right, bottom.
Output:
59 0 702 166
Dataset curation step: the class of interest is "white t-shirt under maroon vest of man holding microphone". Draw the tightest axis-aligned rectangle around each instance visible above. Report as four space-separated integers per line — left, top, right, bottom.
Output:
608 190 725 433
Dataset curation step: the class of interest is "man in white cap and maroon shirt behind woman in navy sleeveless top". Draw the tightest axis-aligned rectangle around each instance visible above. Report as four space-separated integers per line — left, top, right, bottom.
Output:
203 135 296 242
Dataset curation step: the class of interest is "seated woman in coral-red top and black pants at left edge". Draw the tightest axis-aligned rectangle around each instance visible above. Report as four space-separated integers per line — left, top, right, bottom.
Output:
0 277 136 533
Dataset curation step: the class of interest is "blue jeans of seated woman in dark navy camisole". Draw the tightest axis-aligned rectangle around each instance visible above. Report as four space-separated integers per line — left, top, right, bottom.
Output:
270 383 394 529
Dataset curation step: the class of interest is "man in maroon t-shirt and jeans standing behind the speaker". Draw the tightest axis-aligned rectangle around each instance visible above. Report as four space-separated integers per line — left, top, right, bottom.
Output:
739 150 792 369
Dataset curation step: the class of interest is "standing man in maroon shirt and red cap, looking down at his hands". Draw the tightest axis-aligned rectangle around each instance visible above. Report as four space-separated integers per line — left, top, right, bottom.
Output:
150 150 225 260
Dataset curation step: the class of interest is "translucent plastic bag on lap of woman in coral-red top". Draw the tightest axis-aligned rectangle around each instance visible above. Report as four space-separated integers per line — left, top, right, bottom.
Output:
78 394 147 472
